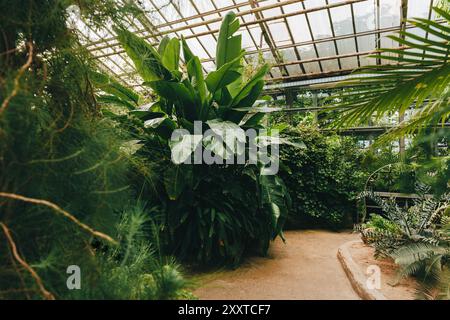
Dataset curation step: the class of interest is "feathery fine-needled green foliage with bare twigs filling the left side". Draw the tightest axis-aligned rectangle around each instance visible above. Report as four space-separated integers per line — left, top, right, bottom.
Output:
0 0 188 299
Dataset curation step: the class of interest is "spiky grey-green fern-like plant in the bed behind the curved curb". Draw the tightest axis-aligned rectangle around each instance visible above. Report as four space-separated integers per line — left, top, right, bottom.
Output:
357 185 450 299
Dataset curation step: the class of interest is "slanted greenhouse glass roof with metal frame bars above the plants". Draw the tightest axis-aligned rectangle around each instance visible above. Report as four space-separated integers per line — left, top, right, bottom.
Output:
76 0 437 90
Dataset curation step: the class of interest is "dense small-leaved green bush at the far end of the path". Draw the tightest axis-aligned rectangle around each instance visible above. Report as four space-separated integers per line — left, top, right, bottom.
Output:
280 126 365 229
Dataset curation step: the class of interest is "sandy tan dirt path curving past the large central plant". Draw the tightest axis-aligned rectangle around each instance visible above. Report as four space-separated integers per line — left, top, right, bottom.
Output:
194 231 359 300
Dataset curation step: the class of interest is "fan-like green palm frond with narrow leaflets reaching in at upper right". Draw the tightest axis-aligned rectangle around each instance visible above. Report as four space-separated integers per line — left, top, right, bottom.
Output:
332 8 450 141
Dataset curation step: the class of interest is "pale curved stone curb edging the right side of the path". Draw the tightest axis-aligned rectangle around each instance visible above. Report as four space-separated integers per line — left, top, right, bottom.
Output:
337 240 387 300
